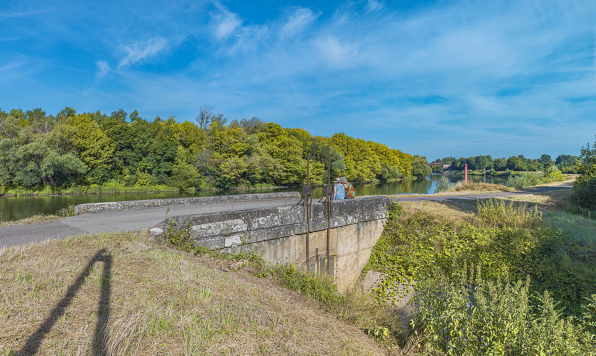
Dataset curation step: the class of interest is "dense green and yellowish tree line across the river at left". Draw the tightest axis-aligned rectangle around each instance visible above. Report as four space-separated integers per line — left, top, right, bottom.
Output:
0 106 414 190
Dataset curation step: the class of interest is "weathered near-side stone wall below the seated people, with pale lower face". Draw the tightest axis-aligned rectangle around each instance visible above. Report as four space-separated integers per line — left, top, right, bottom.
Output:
154 197 391 291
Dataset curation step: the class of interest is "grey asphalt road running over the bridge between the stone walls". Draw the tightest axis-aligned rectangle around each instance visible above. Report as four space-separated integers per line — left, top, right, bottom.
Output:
0 200 288 247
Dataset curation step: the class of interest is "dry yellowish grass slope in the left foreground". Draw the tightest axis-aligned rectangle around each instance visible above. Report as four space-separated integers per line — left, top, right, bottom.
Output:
0 233 385 355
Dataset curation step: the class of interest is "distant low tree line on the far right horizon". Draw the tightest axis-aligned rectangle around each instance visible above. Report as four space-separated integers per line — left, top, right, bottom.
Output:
434 154 581 173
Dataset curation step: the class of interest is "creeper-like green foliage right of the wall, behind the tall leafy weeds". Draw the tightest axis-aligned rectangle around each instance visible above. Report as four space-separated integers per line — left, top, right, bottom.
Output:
365 201 596 315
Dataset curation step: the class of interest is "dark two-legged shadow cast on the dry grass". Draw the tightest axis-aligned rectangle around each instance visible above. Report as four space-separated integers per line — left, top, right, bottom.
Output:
17 249 112 356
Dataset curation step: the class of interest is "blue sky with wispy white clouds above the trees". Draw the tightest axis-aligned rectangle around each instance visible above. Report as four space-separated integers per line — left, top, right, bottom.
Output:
0 0 596 159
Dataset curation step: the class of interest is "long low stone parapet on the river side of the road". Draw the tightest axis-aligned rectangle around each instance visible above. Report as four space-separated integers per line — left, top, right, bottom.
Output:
74 192 300 215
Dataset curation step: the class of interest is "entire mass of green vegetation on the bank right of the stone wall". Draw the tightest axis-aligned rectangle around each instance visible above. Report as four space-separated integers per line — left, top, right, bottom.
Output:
363 199 596 355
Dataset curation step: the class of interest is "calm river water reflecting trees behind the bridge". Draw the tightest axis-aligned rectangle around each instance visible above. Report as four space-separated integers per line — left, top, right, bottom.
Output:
0 175 504 221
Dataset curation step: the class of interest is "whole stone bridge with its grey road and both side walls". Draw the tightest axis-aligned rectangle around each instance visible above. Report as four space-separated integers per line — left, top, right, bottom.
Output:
0 192 391 291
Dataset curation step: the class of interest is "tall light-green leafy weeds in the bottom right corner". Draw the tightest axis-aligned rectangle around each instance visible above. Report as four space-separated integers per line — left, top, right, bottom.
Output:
411 267 596 356
